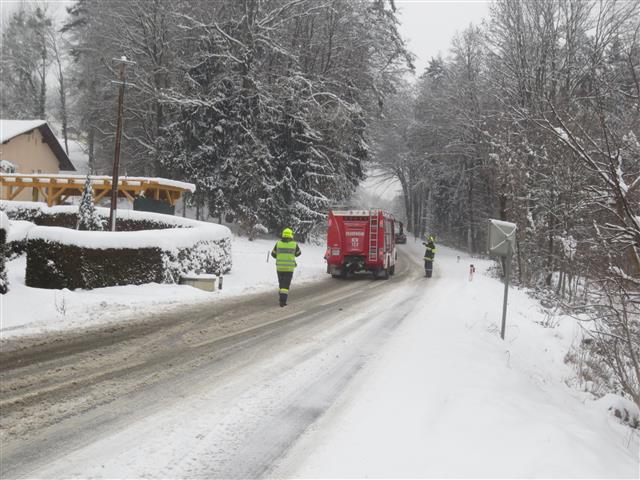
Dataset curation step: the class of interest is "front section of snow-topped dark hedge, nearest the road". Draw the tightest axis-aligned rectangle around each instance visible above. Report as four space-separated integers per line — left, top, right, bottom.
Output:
26 222 231 289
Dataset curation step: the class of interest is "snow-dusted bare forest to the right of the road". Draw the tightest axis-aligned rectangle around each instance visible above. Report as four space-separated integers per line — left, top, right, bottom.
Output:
374 0 640 405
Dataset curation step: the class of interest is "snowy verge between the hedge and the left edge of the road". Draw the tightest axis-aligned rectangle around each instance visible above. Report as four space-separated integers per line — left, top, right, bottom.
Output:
0 236 326 339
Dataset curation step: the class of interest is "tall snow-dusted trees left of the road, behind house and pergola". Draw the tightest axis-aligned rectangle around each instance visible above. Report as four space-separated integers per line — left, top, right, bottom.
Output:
2 0 412 238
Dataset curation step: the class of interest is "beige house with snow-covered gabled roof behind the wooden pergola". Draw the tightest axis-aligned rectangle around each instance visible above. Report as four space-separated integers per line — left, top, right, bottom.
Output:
0 120 75 200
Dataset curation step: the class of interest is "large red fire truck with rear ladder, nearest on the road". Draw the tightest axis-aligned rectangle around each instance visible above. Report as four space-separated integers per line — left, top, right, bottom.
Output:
325 210 396 279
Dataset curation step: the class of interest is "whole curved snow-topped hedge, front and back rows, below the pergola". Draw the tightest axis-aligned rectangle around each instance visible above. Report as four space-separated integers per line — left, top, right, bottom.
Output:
3 202 231 289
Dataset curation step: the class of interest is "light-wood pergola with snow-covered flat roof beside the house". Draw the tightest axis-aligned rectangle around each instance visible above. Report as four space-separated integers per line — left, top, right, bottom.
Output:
0 173 196 206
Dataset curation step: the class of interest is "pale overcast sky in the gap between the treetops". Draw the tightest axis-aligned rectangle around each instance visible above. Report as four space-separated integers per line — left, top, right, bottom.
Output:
396 0 489 75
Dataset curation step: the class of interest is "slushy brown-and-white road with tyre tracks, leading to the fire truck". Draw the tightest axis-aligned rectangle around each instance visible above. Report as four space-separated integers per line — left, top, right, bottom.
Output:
0 248 424 478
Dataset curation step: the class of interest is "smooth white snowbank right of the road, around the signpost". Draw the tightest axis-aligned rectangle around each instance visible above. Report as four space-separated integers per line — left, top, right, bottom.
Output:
275 240 640 478
